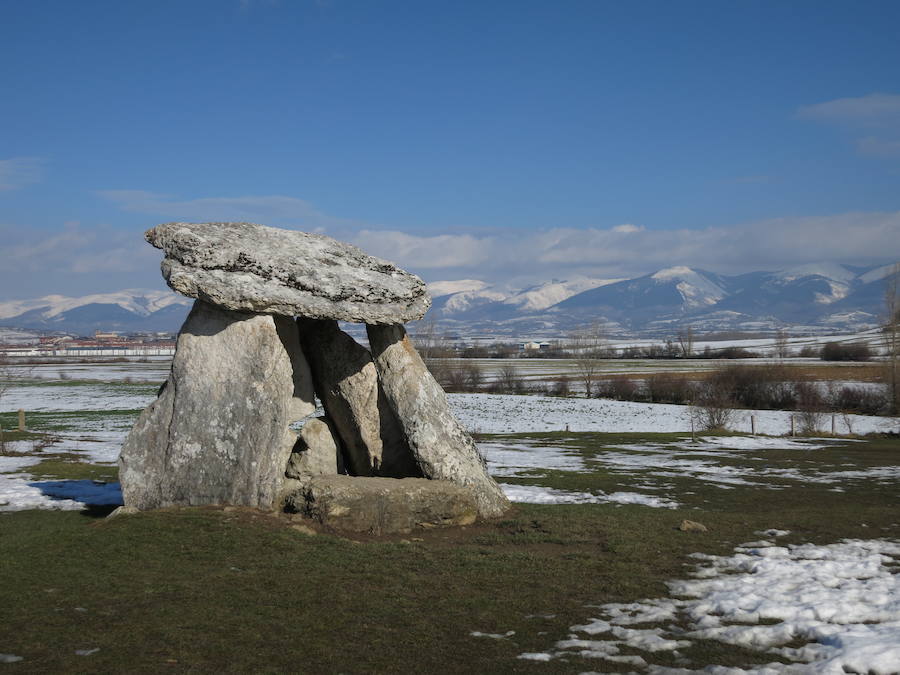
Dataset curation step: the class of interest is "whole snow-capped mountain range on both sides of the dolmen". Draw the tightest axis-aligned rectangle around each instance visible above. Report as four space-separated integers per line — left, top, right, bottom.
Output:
0 263 895 338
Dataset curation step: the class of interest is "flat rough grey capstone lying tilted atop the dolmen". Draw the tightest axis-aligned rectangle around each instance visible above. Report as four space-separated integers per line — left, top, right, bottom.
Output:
144 223 431 324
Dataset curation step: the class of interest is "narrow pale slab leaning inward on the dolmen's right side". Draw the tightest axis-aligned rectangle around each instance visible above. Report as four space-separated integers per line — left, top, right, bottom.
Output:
367 325 509 517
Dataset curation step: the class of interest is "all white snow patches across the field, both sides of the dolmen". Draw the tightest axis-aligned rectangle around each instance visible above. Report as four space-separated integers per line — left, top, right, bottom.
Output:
0 370 900 675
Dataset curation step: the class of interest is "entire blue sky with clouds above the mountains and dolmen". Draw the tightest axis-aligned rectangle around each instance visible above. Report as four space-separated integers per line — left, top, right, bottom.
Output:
0 0 900 298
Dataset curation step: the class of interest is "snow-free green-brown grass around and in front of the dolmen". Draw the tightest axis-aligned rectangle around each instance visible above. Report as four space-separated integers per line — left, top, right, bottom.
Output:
0 424 900 673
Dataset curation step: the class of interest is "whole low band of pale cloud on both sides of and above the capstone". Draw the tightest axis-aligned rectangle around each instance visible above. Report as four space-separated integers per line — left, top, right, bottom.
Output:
7 191 900 297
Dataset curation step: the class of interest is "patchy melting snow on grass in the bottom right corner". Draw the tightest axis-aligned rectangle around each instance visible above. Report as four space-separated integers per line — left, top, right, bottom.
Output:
519 530 900 675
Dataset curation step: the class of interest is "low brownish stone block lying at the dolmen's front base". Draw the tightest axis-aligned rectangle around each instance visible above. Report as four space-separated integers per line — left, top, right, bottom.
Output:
285 476 478 534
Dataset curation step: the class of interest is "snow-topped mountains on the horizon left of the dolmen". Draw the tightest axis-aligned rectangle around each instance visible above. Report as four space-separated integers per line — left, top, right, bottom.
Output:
0 289 193 334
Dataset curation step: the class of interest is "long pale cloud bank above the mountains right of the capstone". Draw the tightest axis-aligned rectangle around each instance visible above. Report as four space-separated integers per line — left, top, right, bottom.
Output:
344 212 900 280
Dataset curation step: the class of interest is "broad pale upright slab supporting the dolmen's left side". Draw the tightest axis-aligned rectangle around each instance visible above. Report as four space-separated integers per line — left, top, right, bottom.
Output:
119 301 314 509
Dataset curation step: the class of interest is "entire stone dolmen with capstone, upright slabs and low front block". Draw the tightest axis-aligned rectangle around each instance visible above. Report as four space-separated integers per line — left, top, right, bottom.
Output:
119 223 509 533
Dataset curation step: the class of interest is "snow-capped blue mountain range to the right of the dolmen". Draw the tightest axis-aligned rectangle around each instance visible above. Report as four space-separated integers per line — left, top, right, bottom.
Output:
432 263 894 335
